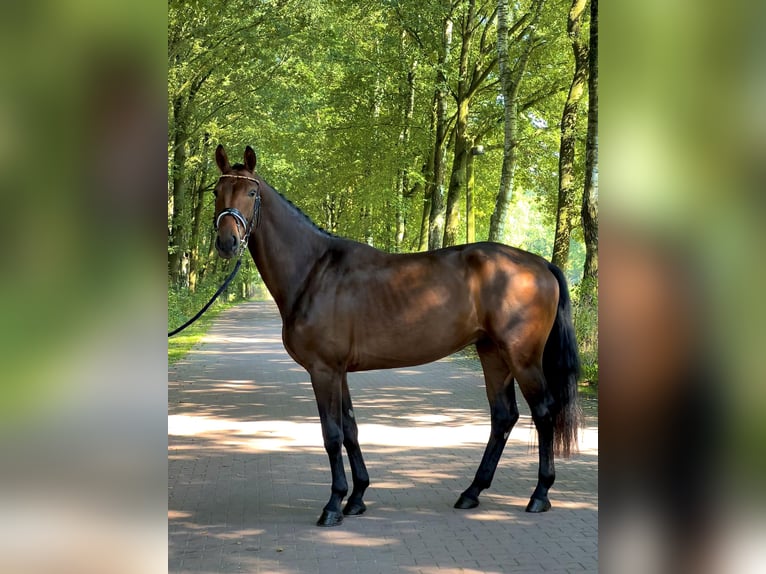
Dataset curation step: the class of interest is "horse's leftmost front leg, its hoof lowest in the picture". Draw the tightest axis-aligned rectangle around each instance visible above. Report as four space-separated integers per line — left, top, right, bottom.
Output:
310 367 348 526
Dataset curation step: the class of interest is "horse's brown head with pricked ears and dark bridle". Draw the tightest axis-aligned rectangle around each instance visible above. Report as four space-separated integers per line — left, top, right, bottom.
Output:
213 145 261 259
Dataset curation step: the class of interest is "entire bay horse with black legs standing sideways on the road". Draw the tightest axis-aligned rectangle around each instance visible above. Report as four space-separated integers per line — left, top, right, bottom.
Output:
214 145 580 526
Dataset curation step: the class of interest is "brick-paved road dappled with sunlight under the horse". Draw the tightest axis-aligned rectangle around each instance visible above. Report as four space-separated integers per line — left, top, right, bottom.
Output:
168 303 598 574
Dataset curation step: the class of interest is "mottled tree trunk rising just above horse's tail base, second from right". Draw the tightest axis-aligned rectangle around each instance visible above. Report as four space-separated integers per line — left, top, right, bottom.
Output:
551 0 588 269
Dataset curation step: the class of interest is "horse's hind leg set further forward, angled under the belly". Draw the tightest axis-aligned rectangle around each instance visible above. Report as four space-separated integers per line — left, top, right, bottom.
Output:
455 340 519 508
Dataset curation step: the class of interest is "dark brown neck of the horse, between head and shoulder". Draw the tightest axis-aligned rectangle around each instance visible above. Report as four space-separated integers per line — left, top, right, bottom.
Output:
250 189 330 317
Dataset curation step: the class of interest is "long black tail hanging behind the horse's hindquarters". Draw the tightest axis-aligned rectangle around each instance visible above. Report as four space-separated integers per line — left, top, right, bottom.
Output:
543 263 582 457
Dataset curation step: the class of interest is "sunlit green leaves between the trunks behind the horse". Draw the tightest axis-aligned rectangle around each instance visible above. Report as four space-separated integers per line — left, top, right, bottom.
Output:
168 0 597 378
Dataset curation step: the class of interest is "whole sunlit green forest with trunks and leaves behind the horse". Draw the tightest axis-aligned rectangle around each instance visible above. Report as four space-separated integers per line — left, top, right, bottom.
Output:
167 0 598 379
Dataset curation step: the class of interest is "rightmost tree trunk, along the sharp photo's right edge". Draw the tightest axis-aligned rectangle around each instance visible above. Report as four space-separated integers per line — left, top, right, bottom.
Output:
581 0 598 296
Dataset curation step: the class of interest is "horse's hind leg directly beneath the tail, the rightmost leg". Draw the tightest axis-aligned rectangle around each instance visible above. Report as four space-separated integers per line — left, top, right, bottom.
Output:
514 365 556 512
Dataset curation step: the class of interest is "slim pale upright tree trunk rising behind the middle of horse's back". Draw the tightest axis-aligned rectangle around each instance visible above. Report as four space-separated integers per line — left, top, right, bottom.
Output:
428 14 452 249
